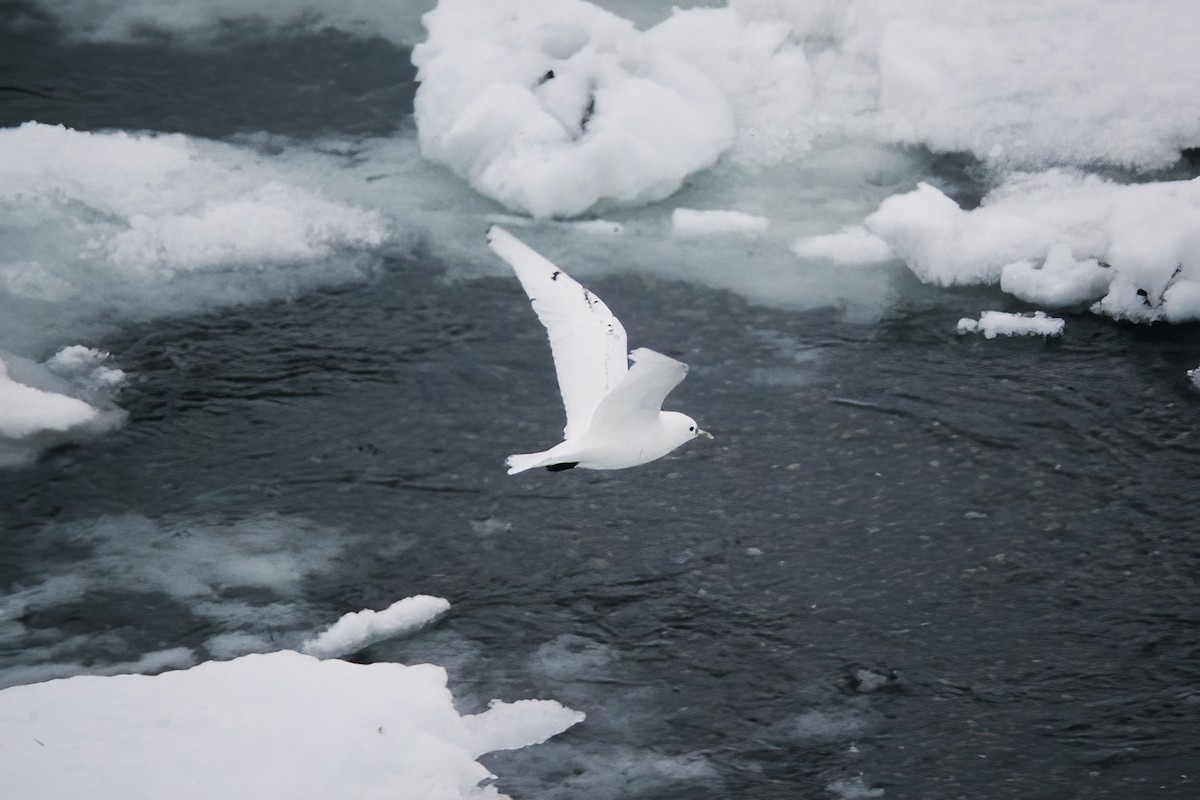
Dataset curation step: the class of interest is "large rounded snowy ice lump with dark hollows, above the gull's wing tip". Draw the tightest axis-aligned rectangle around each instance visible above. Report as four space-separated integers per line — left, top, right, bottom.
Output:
413 0 734 217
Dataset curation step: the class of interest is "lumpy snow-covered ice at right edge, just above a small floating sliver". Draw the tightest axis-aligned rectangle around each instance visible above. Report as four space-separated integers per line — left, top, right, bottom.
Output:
865 169 1200 321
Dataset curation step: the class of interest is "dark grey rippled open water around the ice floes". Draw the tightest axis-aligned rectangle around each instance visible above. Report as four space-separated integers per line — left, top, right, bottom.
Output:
0 12 1200 799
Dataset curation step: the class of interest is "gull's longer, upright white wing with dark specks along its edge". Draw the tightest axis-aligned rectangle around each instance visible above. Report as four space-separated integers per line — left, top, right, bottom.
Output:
487 225 628 439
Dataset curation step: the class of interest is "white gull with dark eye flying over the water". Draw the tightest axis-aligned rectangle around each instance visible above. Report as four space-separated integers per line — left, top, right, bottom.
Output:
487 225 712 475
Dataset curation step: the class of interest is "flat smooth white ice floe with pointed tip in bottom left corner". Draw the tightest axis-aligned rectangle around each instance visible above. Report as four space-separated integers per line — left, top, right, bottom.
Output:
0 651 583 800
